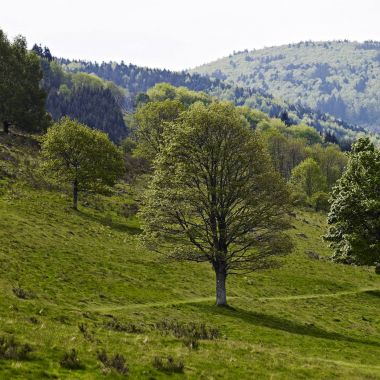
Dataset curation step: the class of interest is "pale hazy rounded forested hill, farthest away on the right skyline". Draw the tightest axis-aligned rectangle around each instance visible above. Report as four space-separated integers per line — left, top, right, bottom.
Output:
192 41 380 128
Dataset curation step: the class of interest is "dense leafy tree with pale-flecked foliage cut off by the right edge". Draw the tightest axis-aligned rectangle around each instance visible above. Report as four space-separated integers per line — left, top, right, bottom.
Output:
325 138 380 265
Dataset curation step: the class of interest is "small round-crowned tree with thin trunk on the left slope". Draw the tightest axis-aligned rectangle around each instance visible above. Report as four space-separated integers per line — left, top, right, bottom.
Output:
42 117 124 210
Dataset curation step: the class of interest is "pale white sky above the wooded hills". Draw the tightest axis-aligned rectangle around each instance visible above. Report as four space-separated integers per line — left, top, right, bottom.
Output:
0 0 380 70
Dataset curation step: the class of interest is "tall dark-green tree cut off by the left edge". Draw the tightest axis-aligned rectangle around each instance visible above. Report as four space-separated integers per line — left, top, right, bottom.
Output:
0 30 50 133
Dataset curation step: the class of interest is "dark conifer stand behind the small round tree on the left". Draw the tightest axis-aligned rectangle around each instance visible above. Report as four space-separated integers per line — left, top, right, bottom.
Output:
33 45 127 141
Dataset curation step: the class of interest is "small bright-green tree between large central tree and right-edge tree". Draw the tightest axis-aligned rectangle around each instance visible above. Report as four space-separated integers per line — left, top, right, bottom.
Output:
290 157 326 197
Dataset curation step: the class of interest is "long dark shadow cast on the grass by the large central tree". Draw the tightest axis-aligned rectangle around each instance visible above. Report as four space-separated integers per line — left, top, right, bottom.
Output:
193 304 380 347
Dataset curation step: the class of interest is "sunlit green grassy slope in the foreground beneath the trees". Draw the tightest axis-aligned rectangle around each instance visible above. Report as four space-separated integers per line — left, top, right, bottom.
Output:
0 133 380 379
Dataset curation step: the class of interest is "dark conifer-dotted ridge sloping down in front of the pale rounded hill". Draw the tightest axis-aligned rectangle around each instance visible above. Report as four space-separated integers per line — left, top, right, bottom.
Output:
57 59 378 149
